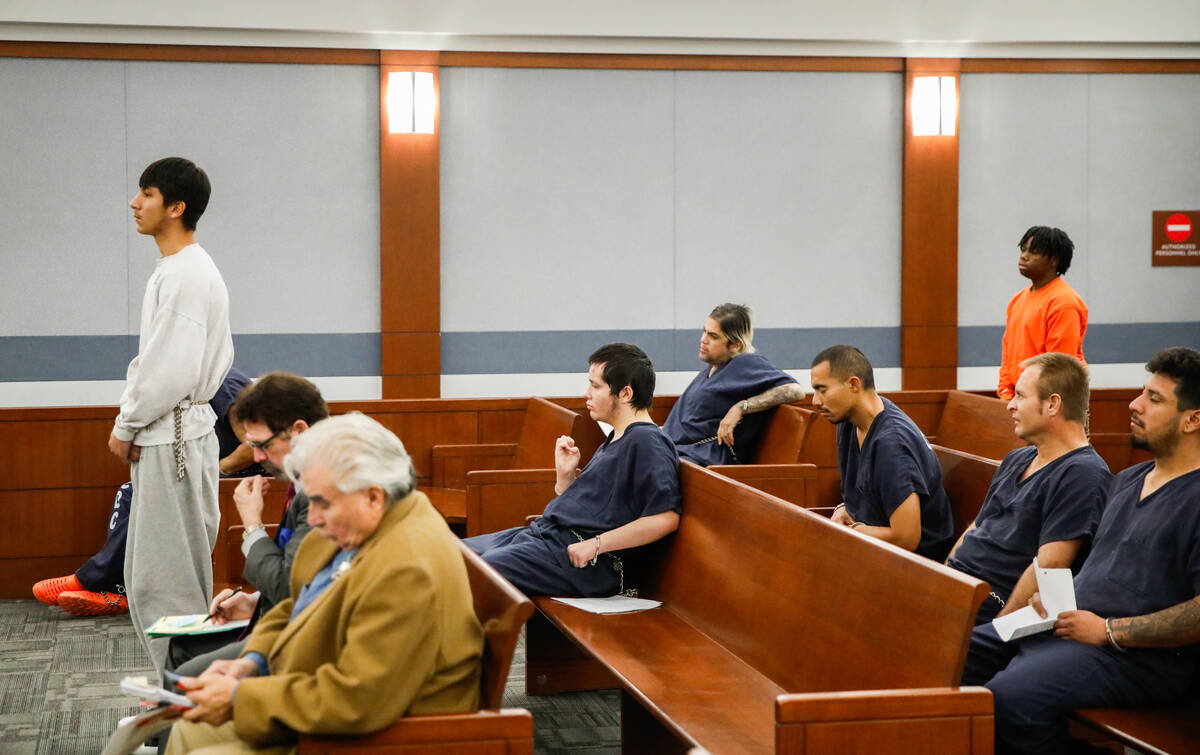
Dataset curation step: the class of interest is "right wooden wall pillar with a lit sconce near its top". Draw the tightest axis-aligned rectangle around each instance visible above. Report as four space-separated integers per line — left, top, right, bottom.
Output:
900 58 960 390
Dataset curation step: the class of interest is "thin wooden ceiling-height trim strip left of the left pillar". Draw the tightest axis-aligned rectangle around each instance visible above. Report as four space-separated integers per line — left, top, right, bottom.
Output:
0 42 379 66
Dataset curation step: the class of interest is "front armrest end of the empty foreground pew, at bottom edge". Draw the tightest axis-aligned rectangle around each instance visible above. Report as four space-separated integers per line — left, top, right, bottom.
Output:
775 687 995 755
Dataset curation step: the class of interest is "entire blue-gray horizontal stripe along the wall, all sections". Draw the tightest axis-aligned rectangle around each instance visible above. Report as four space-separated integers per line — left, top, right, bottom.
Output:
7 322 1200 383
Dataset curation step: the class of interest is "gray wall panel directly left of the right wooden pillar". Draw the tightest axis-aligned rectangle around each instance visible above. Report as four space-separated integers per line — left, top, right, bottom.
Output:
674 71 904 326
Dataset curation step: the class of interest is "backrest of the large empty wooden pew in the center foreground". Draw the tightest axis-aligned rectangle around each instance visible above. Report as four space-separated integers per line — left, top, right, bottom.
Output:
648 462 988 691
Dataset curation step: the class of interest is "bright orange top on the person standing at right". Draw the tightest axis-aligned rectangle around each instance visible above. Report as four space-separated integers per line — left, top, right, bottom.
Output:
996 276 1087 400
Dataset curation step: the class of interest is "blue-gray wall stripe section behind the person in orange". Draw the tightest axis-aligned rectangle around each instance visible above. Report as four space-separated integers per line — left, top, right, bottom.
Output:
959 323 1200 367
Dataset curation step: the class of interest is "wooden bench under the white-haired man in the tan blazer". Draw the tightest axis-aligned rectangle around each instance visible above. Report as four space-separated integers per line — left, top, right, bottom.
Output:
300 543 533 755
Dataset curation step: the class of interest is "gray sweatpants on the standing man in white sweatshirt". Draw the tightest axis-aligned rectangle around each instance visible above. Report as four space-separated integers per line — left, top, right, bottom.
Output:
125 432 221 675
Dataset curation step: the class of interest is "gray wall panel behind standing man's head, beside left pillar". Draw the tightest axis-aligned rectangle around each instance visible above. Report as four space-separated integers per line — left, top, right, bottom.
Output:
127 62 379 332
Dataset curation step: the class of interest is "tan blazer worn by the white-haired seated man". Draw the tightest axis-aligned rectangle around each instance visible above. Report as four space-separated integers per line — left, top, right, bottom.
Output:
234 491 484 747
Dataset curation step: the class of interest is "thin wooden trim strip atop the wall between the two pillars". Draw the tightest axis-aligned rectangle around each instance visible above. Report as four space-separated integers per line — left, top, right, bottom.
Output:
438 52 905 73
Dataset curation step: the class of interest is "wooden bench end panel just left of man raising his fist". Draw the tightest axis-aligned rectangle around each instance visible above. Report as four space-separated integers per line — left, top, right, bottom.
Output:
467 469 558 537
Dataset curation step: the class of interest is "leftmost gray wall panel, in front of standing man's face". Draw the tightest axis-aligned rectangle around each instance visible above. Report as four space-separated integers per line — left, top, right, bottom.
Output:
0 58 132 336
